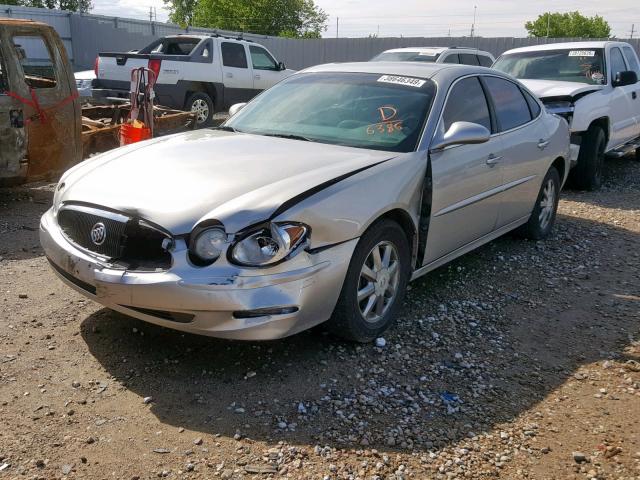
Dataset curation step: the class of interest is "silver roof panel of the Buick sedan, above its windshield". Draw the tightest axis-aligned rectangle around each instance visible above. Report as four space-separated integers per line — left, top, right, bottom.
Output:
303 62 496 79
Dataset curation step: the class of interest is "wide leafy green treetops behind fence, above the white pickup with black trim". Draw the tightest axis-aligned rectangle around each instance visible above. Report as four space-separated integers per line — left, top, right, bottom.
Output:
165 0 328 38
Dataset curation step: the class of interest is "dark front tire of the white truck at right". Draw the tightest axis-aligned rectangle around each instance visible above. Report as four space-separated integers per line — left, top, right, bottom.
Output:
570 125 607 191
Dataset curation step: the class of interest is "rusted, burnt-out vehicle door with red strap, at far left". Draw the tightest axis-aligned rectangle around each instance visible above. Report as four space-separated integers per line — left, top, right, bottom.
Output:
8 26 82 180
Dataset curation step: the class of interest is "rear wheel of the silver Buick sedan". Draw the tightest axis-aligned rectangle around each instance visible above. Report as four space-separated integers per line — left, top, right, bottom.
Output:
518 167 560 240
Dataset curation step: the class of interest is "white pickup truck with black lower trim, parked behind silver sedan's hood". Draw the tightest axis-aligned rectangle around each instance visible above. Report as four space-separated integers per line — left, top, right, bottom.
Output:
92 35 294 125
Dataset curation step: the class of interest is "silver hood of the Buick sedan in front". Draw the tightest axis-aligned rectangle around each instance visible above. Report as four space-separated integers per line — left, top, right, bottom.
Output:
55 130 395 235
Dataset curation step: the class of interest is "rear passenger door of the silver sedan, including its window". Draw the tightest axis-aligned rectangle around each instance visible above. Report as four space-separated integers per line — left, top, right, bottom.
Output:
482 76 554 228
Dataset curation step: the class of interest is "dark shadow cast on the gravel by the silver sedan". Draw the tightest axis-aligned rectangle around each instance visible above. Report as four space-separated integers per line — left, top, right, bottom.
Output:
81 211 640 451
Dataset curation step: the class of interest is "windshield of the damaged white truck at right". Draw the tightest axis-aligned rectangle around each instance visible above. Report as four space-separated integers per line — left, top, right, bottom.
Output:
493 48 606 85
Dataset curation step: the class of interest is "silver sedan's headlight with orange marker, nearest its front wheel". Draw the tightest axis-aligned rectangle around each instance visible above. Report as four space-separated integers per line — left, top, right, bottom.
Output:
231 223 309 267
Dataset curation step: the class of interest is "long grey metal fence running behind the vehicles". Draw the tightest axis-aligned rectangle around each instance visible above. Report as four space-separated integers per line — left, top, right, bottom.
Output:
0 5 640 70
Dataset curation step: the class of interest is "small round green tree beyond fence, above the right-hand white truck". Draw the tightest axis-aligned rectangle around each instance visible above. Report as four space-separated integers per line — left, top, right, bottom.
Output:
524 11 611 38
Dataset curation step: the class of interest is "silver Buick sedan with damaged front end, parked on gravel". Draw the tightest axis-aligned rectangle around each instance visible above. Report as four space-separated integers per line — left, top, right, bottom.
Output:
40 62 569 341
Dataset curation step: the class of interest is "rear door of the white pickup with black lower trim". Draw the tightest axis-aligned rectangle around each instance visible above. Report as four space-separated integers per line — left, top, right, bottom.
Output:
220 40 255 107
